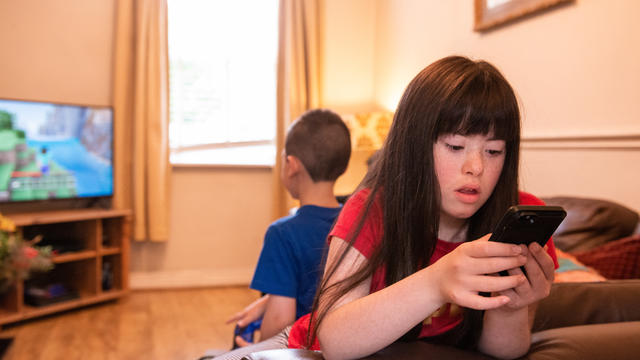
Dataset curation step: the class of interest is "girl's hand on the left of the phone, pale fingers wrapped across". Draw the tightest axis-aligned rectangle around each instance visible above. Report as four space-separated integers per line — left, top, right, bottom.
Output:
430 234 528 310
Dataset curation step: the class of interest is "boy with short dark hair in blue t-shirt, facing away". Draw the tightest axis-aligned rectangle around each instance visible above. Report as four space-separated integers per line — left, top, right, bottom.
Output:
228 109 351 346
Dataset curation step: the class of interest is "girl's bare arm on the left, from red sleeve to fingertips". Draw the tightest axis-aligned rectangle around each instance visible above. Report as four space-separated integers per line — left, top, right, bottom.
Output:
318 237 526 359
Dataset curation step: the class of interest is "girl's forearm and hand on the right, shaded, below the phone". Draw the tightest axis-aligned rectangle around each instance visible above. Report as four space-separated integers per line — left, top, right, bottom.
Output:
479 242 555 358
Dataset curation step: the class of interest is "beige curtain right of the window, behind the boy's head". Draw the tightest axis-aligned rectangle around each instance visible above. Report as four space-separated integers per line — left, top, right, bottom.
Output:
274 0 322 218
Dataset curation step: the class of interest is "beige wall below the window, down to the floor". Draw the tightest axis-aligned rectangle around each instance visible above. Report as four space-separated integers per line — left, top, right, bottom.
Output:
131 167 273 288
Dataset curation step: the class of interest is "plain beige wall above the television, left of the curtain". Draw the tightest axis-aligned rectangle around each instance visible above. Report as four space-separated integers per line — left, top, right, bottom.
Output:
0 0 115 105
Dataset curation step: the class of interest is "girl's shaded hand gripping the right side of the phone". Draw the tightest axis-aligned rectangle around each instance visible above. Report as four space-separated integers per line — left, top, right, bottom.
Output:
500 242 555 310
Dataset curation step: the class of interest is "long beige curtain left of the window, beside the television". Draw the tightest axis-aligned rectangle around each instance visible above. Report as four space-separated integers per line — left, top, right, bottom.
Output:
113 0 171 241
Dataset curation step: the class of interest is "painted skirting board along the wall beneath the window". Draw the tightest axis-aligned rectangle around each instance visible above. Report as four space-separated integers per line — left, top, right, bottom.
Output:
129 267 254 290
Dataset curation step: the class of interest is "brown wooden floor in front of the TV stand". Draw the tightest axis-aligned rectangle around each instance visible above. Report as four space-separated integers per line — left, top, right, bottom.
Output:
0 286 259 360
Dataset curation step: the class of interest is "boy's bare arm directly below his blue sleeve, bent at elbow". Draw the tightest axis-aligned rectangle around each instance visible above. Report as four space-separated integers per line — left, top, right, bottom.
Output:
260 294 296 340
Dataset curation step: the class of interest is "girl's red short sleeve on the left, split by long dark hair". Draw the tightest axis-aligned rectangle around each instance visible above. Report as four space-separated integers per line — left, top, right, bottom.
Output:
329 189 382 258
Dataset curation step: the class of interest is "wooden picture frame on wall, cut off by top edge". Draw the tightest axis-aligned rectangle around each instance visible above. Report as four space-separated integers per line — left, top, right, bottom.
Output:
473 0 574 31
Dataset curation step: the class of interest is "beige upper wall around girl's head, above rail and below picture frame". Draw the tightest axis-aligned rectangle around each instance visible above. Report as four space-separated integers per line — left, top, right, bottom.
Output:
375 0 640 137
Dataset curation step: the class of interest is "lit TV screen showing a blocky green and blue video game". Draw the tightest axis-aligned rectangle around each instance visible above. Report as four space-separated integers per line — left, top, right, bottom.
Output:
0 99 113 203
